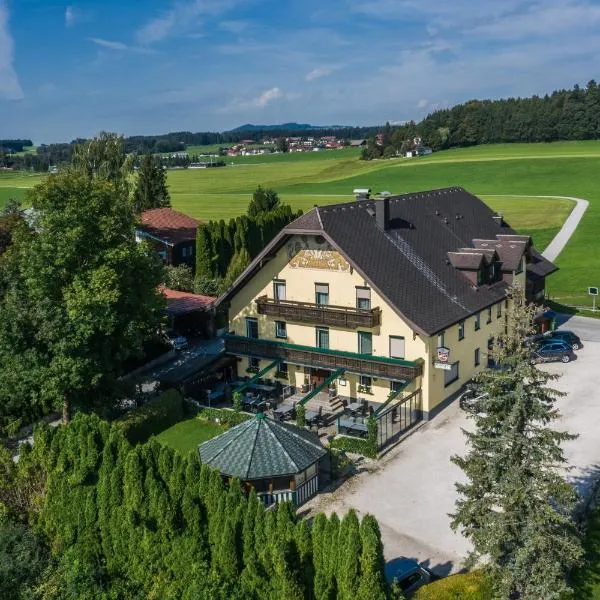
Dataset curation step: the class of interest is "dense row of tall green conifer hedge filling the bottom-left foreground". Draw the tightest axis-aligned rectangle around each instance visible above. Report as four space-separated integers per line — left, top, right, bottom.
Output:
0 414 394 600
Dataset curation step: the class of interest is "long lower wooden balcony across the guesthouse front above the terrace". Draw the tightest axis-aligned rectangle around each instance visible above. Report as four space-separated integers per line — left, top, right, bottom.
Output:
225 335 423 381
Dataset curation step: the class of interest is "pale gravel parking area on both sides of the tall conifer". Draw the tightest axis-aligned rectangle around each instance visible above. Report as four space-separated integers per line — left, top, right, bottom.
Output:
303 318 600 575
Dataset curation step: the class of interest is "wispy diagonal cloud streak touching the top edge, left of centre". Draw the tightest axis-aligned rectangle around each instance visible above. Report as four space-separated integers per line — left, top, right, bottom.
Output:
136 0 239 45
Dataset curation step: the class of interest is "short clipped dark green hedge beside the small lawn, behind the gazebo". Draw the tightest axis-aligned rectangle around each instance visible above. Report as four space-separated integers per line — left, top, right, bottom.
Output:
114 390 184 444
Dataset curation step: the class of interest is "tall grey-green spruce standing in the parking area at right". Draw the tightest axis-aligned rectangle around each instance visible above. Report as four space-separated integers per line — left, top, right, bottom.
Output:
452 287 581 600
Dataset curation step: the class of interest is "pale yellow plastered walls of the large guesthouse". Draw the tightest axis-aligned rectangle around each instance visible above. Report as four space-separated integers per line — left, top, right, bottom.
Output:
229 236 524 416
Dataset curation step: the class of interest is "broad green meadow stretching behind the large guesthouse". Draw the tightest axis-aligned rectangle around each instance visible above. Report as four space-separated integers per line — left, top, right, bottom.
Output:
0 141 600 306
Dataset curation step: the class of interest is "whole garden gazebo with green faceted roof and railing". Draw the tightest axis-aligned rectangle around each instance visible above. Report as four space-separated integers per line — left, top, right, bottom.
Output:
199 413 330 506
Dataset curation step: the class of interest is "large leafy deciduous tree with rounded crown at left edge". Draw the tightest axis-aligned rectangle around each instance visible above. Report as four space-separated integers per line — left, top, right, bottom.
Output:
0 172 164 429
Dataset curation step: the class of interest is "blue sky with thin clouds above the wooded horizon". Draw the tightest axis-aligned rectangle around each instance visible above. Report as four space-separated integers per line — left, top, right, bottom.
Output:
0 0 600 142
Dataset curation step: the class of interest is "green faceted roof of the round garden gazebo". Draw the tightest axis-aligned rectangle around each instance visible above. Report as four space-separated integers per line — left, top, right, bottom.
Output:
199 413 327 481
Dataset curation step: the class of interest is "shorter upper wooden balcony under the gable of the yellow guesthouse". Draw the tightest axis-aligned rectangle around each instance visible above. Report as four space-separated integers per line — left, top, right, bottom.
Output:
256 296 381 329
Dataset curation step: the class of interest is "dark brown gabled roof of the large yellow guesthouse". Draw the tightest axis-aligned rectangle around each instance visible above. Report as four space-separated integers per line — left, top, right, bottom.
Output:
219 188 557 335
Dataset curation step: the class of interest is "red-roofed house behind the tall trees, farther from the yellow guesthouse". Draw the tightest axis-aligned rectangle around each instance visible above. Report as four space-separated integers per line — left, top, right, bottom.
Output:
135 208 200 269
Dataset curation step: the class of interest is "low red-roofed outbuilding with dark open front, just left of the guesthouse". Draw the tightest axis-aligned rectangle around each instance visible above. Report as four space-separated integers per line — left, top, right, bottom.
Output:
160 287 216 337
